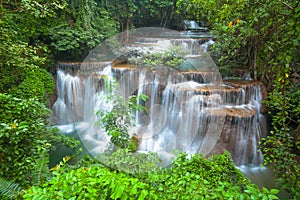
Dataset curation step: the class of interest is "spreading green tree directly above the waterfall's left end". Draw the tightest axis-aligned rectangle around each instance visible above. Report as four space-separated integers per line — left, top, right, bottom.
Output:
49 1 116 60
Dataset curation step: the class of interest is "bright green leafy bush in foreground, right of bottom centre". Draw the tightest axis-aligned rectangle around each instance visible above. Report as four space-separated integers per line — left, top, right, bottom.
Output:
151 152 278 199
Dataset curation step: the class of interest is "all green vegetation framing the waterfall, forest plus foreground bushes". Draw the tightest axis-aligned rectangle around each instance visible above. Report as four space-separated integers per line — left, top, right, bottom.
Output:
0 0 300 199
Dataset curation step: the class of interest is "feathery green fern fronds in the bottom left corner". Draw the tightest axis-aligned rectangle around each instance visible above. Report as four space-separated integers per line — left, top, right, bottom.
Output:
0 177 23 199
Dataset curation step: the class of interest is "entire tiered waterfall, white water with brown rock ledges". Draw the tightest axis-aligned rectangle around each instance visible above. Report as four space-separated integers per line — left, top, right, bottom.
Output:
51 27 266 166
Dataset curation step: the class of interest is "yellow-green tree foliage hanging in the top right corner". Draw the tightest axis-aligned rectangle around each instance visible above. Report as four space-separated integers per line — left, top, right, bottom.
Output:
177 0 300 83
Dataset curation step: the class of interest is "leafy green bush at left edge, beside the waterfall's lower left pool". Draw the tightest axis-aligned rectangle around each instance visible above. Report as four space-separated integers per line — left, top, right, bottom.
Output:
0 93 77 186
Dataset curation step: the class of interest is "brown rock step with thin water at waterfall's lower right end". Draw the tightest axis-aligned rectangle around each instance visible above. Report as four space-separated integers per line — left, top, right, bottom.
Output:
210 108 266 166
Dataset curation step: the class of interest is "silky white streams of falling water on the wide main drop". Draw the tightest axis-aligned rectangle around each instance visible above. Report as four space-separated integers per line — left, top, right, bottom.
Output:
53 70 263 165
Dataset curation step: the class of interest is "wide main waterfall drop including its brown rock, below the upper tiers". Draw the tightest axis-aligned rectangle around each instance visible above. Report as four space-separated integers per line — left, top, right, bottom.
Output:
52 33 264 165
